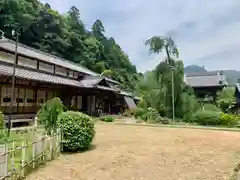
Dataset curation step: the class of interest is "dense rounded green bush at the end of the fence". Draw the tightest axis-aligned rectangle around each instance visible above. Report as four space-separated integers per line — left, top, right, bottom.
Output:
58 111 95 152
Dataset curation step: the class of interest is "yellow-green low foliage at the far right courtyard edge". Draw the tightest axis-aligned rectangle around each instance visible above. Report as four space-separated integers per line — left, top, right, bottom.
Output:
219 113 240 127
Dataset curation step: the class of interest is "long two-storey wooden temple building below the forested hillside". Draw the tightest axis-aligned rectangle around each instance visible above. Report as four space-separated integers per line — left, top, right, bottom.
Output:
0 39 139 126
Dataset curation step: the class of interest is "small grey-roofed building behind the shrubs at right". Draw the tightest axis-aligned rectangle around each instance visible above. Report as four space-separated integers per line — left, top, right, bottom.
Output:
184 71 228 103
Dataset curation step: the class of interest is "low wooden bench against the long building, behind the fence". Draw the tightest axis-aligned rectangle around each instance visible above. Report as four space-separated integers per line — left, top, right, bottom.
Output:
4 114 36 128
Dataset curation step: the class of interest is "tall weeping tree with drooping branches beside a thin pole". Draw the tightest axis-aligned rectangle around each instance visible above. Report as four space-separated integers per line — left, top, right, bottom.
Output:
145 36 183 119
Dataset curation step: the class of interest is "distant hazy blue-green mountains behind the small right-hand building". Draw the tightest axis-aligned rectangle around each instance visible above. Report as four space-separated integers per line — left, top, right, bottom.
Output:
184 65 240 85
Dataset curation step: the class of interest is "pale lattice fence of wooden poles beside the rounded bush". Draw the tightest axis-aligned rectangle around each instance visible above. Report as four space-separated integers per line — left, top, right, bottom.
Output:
0 129 61 180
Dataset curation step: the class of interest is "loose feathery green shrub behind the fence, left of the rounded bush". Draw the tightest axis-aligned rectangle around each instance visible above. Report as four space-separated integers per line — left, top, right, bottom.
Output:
37 97 65 134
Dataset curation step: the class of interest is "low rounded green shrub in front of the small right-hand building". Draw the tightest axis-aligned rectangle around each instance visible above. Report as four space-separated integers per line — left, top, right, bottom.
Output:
194 110 220 125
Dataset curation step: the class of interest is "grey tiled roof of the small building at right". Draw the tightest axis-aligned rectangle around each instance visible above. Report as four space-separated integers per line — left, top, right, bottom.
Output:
186 72 227 87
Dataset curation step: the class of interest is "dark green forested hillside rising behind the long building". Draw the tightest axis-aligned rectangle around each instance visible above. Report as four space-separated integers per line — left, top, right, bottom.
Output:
0 0 138 90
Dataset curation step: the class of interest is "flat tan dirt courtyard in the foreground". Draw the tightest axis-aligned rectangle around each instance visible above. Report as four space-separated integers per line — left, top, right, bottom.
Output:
27 124 240 180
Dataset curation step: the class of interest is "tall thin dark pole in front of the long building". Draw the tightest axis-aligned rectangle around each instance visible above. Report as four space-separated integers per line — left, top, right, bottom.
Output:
8 31 19 136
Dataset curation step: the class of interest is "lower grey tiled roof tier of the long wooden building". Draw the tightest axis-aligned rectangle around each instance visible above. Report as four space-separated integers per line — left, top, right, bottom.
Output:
0 64 83 87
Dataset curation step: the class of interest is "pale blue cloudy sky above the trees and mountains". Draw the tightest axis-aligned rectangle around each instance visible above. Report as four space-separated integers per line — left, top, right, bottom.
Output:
41 0 240 72
